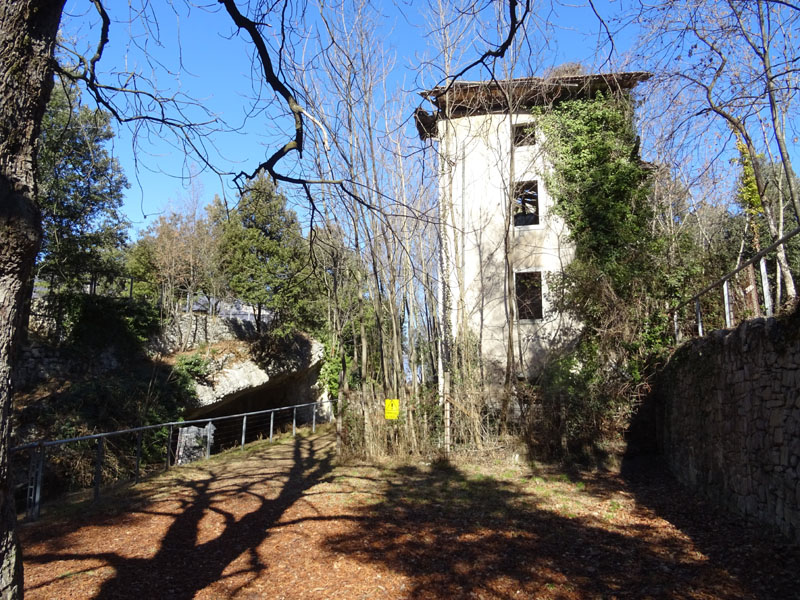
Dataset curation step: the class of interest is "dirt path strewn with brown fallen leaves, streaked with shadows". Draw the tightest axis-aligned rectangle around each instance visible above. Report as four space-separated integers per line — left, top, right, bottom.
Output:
22 434 800 600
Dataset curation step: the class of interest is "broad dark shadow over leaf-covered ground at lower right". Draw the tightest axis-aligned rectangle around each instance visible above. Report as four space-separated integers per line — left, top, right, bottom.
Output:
326 463 797 599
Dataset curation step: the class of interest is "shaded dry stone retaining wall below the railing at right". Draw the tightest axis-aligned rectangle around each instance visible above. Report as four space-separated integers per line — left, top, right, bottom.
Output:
654 314 800 542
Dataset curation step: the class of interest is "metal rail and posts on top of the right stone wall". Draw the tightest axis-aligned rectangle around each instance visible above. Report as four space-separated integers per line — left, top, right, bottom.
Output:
672 227 800 341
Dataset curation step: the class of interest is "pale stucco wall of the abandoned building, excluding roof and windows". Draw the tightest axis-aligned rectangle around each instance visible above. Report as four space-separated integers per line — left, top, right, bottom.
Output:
438 113 573 379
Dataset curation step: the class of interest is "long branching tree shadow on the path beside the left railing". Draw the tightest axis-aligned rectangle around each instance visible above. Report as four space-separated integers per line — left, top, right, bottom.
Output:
26 436 334 599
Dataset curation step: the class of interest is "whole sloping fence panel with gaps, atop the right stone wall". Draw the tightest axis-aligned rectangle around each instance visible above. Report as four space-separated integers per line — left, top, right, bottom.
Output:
672 227 800 342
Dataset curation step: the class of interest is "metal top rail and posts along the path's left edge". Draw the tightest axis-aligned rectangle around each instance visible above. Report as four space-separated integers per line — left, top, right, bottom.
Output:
10 400 336 521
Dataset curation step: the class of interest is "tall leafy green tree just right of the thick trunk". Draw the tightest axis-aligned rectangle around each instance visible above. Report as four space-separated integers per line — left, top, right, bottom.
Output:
36 76 128 291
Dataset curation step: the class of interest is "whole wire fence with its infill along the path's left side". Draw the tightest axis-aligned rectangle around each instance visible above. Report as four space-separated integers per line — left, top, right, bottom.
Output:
11 400 336 521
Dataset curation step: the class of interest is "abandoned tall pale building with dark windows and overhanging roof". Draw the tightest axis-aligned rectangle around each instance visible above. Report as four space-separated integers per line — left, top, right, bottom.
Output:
415 72 650 381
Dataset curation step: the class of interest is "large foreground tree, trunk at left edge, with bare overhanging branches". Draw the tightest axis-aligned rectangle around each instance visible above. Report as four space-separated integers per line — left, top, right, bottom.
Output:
0 0 529 598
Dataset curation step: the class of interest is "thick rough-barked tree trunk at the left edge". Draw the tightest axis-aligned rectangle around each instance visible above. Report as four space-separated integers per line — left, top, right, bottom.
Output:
0 0 64 600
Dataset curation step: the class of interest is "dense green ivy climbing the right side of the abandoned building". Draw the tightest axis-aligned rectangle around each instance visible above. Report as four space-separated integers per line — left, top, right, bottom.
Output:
536 93 680 452
